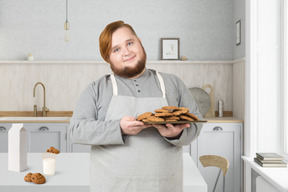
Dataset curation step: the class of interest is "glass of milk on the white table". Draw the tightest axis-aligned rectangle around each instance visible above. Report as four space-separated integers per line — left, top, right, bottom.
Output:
42 153 56 176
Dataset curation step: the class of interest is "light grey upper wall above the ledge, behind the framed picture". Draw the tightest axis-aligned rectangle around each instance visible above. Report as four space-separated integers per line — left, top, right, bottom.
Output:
0 0 241 61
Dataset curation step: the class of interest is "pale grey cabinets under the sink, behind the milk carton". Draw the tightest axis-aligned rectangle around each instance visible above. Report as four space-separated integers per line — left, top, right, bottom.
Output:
0 123 69 153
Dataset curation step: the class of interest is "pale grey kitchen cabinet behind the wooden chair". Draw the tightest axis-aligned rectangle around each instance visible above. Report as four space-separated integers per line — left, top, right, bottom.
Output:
190 123 243 192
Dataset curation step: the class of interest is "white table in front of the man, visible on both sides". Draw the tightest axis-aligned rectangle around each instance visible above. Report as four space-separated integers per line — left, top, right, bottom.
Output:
0 153 207 192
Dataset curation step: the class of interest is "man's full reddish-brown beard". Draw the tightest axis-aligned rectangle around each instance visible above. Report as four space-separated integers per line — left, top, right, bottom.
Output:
110 46 146 78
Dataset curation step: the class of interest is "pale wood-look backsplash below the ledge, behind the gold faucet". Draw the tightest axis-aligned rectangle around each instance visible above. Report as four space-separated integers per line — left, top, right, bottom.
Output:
0 59 245 119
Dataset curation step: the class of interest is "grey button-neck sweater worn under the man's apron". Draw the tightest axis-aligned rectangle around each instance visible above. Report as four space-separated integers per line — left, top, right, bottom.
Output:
70 69 202 146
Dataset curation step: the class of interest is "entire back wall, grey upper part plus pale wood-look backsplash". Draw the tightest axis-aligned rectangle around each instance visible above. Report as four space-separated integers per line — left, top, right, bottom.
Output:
0 0 245 118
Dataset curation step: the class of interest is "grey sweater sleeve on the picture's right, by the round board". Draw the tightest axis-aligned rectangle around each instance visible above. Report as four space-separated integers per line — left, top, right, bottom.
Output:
165 75 203 146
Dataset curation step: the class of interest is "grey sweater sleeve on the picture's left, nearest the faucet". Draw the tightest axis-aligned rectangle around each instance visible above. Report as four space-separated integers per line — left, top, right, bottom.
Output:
70 81 124 145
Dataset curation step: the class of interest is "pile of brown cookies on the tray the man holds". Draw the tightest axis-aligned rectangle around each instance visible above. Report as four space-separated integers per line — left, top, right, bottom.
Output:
137 106 199 122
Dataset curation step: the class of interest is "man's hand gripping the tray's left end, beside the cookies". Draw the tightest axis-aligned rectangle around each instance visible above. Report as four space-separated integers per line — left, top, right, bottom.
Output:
120 116 151 135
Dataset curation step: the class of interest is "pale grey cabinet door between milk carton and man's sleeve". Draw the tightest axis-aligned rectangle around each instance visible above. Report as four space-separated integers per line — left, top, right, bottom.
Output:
24 123 67 153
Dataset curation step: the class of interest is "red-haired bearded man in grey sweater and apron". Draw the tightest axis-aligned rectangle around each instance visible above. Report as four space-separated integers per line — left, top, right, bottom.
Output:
70 21 202 192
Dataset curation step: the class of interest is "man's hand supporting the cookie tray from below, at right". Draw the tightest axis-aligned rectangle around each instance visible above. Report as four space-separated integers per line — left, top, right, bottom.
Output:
152 123 190 139
